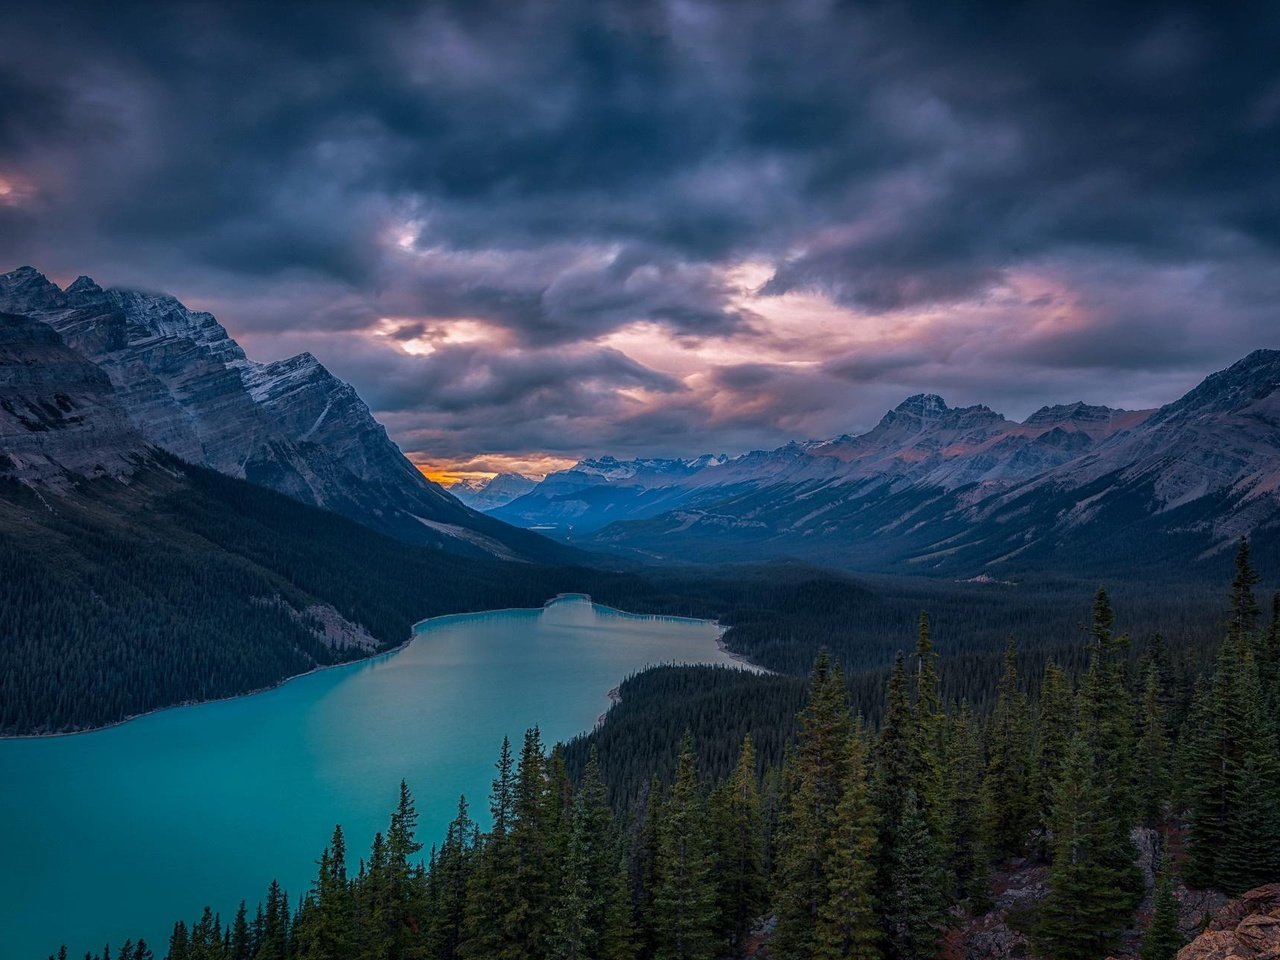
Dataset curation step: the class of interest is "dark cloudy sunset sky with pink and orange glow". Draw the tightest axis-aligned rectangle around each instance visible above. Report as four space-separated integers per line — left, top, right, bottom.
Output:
0 0 1280 476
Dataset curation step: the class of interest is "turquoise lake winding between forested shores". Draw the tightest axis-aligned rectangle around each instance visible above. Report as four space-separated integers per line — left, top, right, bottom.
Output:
0 596 747 960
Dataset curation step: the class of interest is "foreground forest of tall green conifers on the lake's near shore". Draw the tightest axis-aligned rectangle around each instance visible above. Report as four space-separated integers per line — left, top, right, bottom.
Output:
59 543 1280 960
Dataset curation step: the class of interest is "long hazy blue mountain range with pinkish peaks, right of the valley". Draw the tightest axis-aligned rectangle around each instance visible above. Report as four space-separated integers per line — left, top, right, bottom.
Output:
492 349 1280 577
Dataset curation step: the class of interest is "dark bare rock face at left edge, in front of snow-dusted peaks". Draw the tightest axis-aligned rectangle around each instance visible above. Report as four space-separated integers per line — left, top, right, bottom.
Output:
0 314 151 490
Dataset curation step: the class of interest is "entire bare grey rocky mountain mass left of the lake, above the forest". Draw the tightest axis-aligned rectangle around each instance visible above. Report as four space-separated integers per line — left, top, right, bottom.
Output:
0 266 568 559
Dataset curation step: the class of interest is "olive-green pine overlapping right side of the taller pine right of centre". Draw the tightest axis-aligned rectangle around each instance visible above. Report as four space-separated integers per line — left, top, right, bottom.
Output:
813 731 885 960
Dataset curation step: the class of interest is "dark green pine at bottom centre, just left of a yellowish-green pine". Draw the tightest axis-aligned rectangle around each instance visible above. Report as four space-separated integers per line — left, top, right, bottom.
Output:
654 732 717 960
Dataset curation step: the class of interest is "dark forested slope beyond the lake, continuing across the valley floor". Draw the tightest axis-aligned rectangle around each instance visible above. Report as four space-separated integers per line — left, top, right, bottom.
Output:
0 454 1239 735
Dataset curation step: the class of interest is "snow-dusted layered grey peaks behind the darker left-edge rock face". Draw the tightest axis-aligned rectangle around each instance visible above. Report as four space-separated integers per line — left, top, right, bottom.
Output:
0 266 566 559
